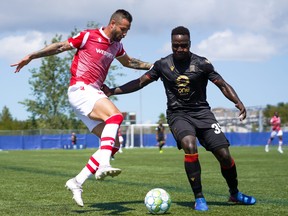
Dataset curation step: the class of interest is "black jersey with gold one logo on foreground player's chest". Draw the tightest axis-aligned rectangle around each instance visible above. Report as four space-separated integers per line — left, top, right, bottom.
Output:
146 53 221 111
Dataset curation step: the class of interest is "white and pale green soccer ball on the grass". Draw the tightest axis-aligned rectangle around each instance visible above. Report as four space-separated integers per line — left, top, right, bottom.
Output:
144 188 171 214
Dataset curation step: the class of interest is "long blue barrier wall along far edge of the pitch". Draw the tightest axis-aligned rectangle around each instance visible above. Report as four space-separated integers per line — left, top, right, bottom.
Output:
0 132 288 150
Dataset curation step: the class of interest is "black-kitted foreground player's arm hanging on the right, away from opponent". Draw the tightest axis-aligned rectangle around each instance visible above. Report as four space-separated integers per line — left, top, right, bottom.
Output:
214 79 246 121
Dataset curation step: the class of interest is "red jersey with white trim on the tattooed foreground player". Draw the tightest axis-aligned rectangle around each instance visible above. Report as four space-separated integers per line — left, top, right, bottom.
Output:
68 28 125 89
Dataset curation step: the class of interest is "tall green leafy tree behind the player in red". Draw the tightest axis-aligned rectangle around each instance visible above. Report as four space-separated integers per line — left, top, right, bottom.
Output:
20 35 72 128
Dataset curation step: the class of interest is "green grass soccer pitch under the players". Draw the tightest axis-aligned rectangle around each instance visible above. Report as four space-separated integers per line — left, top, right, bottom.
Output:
0 146 288 216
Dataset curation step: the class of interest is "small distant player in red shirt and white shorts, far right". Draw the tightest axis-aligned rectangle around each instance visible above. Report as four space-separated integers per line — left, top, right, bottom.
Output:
265 112 283 154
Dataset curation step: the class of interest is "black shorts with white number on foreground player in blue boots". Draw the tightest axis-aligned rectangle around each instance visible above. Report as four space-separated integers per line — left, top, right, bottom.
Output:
167 109 230 152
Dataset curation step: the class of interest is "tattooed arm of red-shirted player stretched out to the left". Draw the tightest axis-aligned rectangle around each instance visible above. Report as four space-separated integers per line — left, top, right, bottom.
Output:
10 41 73 73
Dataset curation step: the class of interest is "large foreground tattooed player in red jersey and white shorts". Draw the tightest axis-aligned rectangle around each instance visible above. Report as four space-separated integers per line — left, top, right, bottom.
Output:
11 9 152 206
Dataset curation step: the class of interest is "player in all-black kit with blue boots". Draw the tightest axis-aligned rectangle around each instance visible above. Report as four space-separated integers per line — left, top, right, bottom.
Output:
103 26 256 211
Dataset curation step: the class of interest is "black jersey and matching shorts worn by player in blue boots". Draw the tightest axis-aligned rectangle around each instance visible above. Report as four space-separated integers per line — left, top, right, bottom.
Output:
146 53 229 152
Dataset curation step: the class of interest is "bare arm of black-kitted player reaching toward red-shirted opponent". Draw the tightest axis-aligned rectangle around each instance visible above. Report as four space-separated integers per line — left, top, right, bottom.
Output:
101 74 154 97
